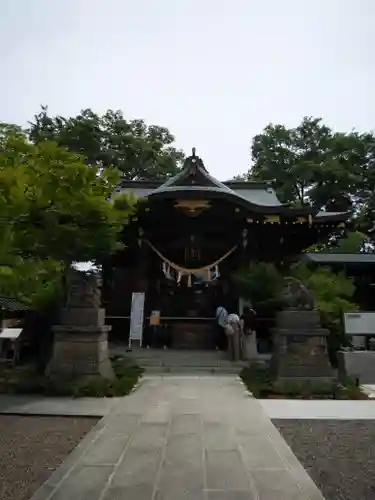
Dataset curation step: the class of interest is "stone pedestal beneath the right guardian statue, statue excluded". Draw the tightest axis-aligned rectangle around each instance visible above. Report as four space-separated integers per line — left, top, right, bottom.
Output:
271 310 334 383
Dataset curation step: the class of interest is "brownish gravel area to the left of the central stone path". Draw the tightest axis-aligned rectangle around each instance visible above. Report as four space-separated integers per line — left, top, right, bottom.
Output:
0 415 97 500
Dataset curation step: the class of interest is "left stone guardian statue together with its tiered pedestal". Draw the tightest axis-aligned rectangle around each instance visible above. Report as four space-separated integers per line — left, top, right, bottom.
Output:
46 272 115 379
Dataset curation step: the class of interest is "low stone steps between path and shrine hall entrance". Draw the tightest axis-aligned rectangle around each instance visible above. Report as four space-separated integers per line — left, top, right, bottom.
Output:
110 345 256 375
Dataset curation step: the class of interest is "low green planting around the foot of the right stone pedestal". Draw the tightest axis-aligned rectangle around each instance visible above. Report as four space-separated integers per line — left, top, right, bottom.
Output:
240 363 368 399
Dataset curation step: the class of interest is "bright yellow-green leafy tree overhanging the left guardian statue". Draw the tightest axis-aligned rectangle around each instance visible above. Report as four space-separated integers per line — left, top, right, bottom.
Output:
0 125 133 304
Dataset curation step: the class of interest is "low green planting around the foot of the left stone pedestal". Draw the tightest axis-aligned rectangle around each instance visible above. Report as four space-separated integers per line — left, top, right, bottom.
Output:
0 359 143 398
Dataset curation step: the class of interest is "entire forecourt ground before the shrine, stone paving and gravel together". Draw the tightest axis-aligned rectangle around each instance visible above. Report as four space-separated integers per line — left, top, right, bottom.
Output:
0 382 375 500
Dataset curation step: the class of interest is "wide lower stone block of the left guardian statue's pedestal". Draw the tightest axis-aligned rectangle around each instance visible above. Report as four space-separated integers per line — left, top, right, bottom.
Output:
46 325 115 379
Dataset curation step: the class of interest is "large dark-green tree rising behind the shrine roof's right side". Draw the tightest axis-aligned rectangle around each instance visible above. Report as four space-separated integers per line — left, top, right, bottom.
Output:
247 117 375 215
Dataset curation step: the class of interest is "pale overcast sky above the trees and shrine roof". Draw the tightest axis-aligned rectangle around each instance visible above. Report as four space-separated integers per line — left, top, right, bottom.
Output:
0 0 375 180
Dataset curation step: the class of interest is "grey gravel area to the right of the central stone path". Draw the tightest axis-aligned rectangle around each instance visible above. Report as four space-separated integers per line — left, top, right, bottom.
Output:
273 420 375 500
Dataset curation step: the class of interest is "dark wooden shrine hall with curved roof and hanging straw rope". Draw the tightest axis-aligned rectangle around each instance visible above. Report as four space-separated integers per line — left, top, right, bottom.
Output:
103 149 347 349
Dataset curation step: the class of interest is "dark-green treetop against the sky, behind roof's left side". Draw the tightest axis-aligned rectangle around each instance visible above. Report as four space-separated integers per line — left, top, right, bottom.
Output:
29 106 183 180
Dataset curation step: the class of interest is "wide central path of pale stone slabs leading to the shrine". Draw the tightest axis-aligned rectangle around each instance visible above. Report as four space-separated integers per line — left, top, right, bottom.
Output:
33 376 324 500
